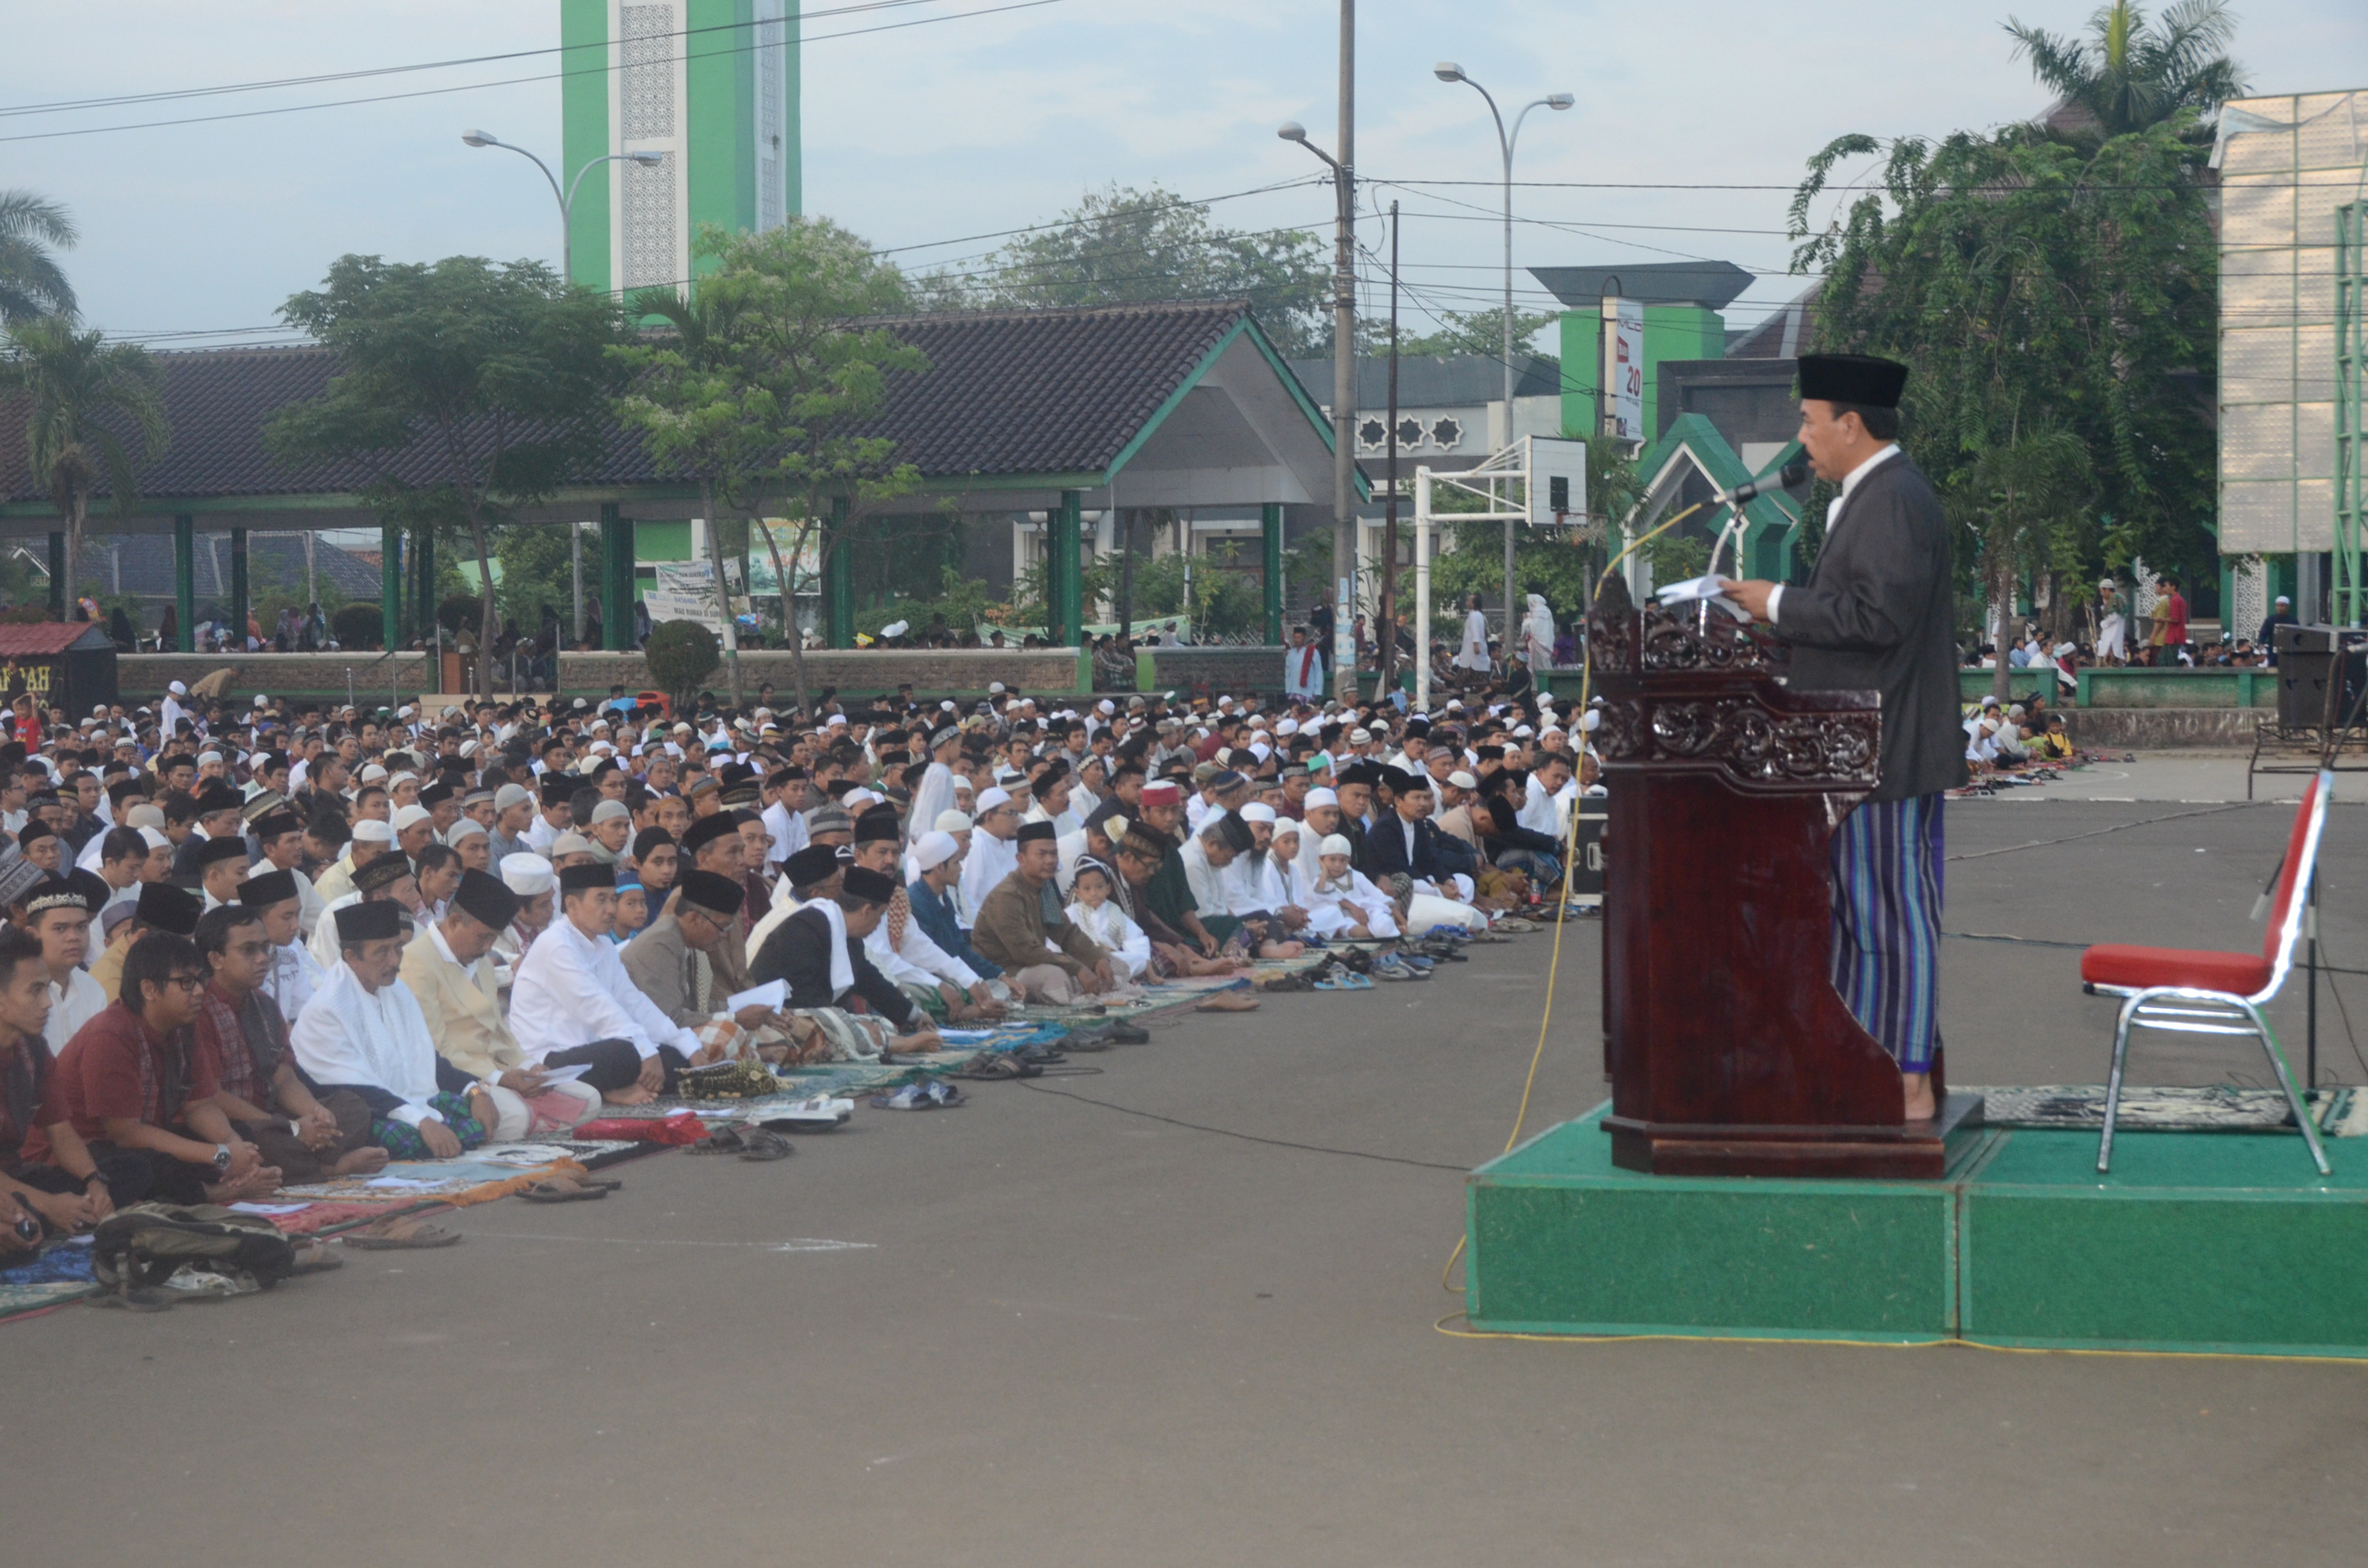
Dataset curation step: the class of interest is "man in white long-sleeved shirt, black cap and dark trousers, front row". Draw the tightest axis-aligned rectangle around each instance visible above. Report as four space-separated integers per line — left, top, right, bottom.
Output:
509 865 720 1106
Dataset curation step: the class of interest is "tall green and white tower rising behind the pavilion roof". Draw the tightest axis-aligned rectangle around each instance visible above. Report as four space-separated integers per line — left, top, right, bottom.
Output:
559 0 803 291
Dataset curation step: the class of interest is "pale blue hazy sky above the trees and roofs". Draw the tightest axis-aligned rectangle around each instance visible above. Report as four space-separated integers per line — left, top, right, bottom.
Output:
0 0 2368 348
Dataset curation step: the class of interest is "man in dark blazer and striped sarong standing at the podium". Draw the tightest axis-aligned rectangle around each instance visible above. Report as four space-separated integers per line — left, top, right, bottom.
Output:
1722 353 1966 1123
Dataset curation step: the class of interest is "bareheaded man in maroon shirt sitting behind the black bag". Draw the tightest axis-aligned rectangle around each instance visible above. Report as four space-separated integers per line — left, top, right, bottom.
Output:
24 931 279 1205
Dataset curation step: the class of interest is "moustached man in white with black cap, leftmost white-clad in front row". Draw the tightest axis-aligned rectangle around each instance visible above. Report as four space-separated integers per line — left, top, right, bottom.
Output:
289 902 495 1161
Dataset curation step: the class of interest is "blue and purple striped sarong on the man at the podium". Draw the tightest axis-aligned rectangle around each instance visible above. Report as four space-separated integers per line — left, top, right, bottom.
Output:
1830 796 1942 1073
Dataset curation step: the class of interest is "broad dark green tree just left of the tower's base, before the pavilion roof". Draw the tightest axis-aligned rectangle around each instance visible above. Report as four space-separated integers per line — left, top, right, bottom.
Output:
263 256 618 692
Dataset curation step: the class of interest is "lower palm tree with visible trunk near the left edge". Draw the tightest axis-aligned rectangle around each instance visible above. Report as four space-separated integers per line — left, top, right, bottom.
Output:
0 315 173 614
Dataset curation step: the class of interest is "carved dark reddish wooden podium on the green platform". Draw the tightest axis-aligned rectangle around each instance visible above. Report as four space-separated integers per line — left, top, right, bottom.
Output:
1589 580 1982 1180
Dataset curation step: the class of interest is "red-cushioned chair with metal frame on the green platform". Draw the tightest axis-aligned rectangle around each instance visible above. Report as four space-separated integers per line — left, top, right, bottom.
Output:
2079 767 2335 1175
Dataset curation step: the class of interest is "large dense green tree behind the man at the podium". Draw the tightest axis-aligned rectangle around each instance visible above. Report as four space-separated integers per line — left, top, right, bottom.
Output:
1790 109 2219 596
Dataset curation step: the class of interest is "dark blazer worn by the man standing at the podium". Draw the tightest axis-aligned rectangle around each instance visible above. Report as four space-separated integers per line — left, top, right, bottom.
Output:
1776 452 1966 801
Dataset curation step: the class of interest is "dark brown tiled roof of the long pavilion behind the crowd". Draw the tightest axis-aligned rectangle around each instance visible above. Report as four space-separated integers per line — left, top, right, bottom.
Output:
0 301 1278 502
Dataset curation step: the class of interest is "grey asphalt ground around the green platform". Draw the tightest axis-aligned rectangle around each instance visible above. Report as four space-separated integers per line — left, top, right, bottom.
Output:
0 798 2368 1568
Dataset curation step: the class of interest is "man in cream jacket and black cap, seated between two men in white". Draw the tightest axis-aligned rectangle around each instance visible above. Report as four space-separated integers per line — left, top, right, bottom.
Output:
402 872 599 1141
